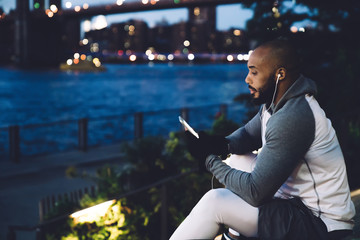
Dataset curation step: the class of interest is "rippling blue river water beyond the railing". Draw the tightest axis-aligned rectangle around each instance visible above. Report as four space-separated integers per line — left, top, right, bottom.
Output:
0 64 248 158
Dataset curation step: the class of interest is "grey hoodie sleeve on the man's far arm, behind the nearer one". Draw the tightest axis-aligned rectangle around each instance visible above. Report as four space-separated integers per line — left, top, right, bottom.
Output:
226 112 261 154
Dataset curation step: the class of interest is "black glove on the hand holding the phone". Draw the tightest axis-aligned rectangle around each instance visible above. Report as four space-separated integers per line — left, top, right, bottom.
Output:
185 131 229 161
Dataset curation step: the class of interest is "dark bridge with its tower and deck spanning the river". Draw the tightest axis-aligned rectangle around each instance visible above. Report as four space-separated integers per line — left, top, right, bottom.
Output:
15 0 245 67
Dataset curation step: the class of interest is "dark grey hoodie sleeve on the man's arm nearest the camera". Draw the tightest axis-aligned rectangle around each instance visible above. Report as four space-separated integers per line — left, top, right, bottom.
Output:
206 97 315 207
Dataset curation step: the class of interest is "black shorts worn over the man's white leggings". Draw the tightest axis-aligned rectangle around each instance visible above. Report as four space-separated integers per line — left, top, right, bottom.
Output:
258 198 328 240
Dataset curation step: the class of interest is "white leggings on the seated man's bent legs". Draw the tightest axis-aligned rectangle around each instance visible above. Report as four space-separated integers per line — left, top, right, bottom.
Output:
170 155 259 240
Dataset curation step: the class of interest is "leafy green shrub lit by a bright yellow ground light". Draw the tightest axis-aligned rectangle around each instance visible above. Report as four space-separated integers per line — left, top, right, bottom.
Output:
47 116 238 240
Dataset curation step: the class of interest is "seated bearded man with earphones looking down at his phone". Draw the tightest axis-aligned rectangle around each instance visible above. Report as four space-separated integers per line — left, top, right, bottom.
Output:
171 40 355 240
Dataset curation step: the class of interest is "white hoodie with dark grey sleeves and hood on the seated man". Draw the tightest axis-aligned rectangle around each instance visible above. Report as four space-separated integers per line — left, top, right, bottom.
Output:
206 76 355 231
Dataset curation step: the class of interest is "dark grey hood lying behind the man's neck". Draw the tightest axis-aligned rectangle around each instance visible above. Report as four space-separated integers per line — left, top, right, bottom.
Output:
271 75 317 112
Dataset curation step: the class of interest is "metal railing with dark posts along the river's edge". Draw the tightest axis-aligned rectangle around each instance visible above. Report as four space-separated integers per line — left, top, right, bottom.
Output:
0 103 245 162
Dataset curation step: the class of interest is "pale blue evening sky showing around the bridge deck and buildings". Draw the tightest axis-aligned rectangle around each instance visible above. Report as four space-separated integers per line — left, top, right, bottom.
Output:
0 0 253 31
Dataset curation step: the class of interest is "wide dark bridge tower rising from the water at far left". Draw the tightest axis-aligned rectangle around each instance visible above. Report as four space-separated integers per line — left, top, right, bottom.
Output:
15 0 73 68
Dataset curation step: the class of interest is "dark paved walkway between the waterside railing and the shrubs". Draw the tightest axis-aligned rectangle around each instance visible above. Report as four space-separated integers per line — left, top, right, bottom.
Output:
0 144 122 240
